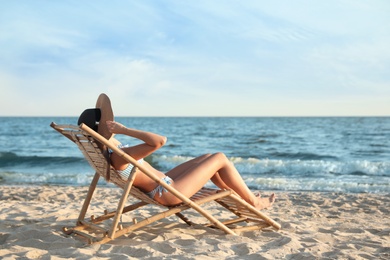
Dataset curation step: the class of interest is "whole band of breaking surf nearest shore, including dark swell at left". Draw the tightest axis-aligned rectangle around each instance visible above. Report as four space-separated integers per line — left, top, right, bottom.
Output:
0 152 390 192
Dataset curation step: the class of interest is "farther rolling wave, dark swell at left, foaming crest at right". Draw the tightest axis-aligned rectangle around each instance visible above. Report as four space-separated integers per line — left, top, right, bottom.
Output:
0 152 390 178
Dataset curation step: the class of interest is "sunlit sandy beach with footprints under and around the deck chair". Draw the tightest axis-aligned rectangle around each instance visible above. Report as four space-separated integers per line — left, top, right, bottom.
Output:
0 186 390 259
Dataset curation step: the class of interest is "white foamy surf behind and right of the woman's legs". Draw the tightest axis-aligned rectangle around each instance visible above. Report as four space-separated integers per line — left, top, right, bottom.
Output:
153 156 390 192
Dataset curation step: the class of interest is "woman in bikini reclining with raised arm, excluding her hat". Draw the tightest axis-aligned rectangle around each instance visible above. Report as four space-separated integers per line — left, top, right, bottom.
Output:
105 120 275 209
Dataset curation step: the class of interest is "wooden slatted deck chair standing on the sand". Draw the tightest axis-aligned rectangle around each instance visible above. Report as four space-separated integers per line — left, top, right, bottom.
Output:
51 122 281 244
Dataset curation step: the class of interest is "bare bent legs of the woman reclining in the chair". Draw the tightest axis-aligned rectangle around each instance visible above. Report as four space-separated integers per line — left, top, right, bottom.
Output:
156 153 275 209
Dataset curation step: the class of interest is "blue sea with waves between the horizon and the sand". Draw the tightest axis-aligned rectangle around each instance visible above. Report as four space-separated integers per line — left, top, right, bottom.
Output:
0 117 390 193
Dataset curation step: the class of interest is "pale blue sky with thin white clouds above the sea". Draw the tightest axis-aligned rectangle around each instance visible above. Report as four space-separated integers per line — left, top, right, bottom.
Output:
0 0 390 116
